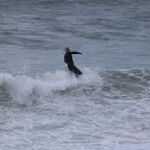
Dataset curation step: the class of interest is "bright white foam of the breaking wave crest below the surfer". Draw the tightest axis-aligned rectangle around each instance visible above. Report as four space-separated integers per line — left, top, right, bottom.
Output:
0 69 100 104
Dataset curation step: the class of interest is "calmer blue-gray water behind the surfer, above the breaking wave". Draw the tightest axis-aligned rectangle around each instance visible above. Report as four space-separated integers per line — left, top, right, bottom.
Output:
0 0 150 72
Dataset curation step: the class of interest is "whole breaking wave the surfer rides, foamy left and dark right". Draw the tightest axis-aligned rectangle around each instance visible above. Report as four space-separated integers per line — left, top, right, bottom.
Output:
0 69 150 105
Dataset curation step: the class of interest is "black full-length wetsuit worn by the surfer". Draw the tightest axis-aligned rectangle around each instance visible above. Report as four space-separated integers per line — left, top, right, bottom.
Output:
64 52 82 76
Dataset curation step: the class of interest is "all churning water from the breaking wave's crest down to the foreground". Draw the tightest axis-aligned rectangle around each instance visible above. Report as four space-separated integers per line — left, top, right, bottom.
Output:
0 68 150 150
